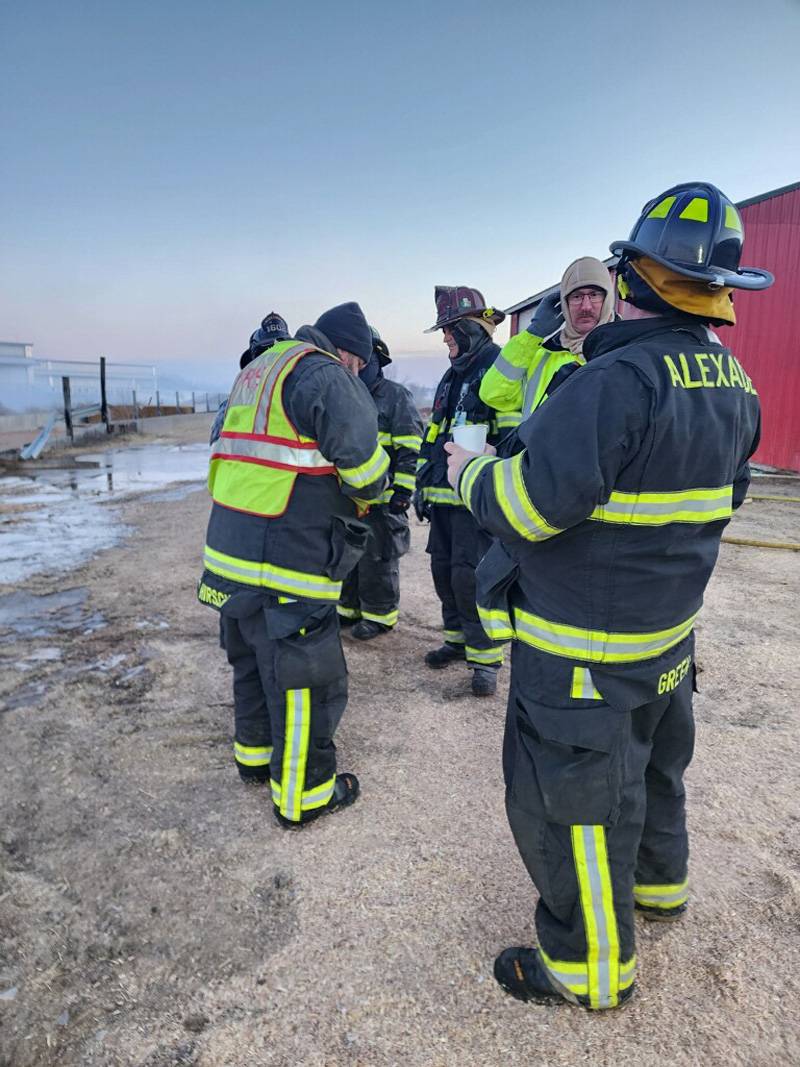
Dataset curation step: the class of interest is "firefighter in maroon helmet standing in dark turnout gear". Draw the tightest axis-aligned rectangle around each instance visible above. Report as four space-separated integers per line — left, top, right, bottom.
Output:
417 285 506 697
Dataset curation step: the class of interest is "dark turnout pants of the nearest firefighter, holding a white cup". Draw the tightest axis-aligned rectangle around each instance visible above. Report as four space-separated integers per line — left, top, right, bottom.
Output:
503 642 694 1008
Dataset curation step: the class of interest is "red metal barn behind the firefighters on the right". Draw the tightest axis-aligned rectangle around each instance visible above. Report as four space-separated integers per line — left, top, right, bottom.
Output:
508 181 800 471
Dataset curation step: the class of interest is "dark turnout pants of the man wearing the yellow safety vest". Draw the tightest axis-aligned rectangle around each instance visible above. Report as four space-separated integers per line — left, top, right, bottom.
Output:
222 596 348 822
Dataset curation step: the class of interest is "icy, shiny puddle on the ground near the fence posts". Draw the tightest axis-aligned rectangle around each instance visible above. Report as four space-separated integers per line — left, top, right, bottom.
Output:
0 444 208 585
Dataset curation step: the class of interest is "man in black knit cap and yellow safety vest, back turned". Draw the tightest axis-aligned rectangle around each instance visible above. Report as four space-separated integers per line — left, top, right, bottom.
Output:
197 303 389 828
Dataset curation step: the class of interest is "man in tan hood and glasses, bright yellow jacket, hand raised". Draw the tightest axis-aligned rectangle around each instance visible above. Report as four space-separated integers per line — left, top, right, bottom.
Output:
480 262 614 456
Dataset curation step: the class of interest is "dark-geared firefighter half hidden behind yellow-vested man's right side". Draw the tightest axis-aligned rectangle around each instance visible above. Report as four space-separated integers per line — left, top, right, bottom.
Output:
338 327 422 641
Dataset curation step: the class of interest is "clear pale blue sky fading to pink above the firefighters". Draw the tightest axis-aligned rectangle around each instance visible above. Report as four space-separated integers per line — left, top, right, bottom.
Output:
0 0 800 386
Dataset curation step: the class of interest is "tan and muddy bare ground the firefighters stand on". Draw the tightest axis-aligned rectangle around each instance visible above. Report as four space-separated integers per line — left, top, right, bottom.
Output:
0 418 800 1067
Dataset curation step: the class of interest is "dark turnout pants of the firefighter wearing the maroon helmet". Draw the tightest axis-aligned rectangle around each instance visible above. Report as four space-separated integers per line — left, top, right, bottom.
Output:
428 504 502 667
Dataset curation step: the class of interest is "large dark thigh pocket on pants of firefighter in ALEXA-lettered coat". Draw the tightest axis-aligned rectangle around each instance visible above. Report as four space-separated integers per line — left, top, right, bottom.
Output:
511 701 629 826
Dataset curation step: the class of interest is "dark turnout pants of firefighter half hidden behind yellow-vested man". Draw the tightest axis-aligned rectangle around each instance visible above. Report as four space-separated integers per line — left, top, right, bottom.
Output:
338 508 411 628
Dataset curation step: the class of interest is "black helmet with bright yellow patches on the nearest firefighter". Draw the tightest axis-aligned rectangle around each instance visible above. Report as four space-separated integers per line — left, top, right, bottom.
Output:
610 181 774 289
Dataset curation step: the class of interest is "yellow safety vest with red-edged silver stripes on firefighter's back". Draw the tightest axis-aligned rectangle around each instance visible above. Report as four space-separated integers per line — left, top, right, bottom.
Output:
208 340 336 517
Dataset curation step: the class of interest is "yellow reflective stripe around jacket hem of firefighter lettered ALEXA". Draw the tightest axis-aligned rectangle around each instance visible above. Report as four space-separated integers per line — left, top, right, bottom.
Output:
514 608 699 663
